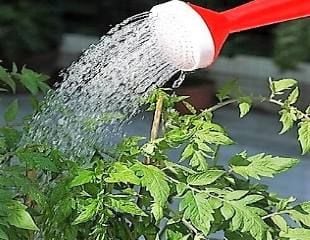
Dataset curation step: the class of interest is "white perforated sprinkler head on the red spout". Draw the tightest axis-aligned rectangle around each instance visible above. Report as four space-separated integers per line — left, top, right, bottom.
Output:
150 0 215 71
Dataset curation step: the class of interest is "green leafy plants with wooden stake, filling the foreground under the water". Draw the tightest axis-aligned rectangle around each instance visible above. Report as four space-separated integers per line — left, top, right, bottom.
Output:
0 64 310 240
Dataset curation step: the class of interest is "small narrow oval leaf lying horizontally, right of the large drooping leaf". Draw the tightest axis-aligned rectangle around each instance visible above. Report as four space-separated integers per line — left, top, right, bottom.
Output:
187 170 225 186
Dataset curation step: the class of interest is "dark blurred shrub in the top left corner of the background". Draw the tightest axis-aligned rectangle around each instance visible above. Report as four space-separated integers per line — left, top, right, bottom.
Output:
0 0 62 61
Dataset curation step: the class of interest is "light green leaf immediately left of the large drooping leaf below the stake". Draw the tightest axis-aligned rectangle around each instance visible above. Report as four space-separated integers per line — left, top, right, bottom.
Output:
105 162 140 185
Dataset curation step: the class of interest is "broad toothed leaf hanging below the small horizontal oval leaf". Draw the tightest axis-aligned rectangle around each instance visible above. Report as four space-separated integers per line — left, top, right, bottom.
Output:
180 191 214 236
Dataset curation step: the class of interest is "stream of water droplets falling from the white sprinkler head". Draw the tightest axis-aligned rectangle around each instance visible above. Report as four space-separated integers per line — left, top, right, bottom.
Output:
28 13 183 156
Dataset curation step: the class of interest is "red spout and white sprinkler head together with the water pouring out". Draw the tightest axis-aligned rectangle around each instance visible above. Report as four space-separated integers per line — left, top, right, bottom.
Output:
25 0 310 158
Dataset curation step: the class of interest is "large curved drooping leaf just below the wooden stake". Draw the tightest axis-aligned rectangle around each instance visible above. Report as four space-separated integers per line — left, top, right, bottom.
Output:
131 163 170 220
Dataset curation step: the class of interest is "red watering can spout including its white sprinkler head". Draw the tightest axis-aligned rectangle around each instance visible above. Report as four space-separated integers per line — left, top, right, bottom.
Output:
150 0 310 71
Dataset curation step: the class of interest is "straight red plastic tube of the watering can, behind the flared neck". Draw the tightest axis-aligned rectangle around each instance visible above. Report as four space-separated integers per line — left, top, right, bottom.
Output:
221 0 310 33
